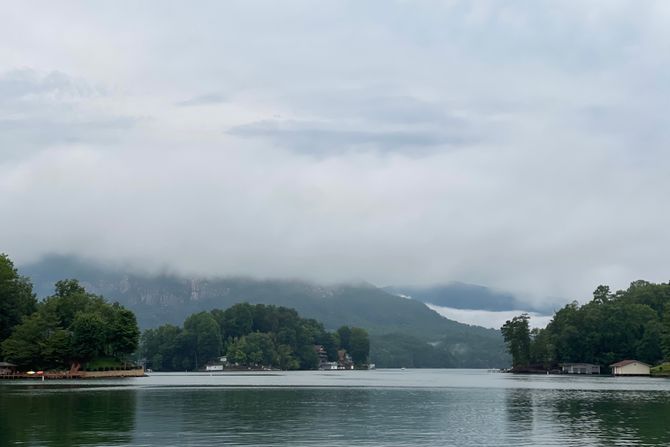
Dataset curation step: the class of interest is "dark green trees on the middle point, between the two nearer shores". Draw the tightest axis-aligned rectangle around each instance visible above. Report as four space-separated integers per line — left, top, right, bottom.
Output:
141 303 370 371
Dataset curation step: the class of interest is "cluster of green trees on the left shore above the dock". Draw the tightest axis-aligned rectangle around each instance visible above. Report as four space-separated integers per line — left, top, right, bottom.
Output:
0 254 140 370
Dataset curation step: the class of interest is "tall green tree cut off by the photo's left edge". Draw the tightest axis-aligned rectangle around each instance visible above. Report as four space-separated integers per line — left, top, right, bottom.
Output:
0 254 37 342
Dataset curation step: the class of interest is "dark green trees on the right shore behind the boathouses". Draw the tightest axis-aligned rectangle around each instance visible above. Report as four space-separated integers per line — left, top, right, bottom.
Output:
501 280 670 370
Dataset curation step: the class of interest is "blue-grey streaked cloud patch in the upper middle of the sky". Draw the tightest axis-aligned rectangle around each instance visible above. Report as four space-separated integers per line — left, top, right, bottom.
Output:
227 94 482 156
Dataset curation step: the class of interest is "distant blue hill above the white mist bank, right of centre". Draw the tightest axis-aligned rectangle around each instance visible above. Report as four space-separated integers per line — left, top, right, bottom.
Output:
384 282 552 312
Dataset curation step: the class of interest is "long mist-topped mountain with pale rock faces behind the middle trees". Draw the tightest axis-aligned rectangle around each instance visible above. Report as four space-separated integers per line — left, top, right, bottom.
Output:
19 256 509 367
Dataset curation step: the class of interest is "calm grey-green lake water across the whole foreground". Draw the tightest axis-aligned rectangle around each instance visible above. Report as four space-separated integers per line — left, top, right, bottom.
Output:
0 370 670 446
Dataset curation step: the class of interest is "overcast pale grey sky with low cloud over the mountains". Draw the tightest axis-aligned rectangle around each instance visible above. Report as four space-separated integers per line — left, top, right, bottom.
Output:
0 0 670 308
